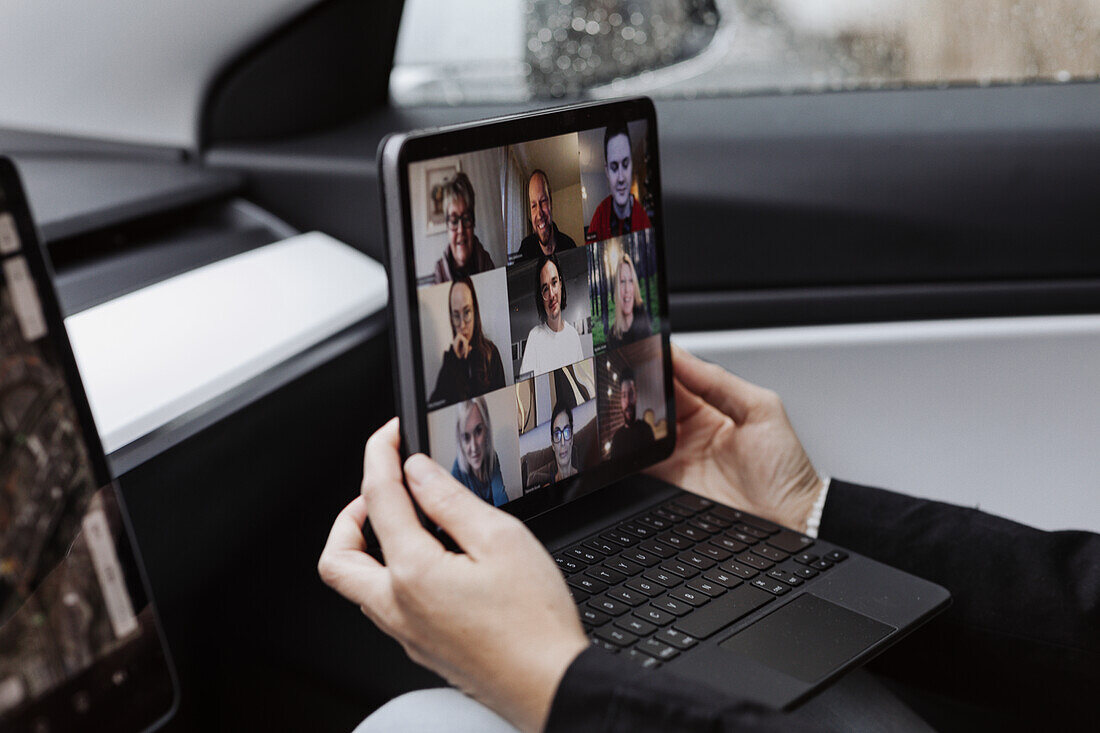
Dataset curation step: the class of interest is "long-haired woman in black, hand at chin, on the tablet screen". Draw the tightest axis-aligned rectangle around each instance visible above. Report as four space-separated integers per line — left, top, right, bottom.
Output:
428 275 505 404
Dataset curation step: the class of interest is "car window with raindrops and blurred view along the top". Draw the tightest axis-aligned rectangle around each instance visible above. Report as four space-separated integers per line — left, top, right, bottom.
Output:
391 0 1100 105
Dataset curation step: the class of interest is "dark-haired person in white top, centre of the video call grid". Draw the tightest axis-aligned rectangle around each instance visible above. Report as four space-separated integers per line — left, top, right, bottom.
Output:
519 254 584 374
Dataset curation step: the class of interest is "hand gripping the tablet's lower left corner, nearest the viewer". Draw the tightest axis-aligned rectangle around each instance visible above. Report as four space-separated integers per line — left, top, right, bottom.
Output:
318 418 589 731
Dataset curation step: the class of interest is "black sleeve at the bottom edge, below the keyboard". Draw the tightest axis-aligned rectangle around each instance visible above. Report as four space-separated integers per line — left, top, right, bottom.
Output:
546 647 803 733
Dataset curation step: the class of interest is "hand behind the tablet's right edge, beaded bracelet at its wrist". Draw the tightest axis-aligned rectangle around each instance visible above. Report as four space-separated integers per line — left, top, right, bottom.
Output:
649 346 822 532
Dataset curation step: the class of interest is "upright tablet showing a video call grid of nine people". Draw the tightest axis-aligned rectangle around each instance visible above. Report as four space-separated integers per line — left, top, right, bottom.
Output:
378 98 675 518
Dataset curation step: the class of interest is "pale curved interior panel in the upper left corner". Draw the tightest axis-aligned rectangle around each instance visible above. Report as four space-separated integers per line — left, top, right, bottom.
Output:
0 0 317 150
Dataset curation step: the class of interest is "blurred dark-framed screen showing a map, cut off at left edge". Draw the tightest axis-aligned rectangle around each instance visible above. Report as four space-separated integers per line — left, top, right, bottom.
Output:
0 157 177 733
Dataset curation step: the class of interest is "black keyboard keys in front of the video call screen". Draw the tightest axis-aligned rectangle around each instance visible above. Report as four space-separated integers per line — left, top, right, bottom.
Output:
554 494 848 668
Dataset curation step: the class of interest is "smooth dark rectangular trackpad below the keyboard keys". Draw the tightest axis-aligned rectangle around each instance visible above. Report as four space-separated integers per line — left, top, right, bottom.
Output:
718 594 897 682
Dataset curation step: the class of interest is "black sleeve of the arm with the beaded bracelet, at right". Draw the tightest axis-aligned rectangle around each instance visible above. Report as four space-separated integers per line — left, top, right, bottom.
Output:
818 480 1100 727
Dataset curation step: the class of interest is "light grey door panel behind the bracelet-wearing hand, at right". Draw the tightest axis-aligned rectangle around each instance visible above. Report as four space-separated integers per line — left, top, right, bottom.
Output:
673 316 1100 532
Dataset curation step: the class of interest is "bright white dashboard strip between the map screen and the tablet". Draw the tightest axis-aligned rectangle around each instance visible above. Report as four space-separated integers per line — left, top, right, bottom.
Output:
65 232 388 452
